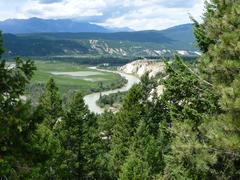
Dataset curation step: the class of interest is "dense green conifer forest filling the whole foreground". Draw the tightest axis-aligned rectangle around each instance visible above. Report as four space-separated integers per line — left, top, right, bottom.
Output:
0 0 240 180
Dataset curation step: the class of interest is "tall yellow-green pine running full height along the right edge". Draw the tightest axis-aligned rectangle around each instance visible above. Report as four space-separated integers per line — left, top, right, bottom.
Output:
193 0 240 179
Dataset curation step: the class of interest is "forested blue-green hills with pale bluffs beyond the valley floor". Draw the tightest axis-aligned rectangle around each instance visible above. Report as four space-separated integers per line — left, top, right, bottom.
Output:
3 24 198 57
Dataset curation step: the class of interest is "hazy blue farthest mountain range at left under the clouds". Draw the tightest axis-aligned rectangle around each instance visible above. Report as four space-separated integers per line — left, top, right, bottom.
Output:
0 18 111 34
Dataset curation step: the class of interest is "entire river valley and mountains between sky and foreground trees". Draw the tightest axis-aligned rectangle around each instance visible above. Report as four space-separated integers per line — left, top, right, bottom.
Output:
0 18 200 113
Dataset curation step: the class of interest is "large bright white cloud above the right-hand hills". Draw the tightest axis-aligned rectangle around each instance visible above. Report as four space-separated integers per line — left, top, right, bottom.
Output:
97 0 204 30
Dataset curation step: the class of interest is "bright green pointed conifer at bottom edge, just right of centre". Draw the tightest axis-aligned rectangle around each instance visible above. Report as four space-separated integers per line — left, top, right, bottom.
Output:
120 120 161 179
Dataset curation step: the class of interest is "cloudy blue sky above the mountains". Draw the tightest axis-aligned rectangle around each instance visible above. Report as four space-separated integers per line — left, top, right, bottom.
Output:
0 0 204 30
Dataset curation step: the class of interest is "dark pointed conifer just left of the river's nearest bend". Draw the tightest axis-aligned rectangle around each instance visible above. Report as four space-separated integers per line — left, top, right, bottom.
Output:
56 93 99 179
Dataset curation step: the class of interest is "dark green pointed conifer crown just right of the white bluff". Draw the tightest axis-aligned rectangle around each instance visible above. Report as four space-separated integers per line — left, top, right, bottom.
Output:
162 57 218 126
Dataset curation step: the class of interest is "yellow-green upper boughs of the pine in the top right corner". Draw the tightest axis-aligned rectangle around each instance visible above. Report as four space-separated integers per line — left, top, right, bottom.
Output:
197 0 240 85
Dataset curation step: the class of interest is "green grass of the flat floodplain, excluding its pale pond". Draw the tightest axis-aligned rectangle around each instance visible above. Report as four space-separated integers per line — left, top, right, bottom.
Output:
27 61 123 95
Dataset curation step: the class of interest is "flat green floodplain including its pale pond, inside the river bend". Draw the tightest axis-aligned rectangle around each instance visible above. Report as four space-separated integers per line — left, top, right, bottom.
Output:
26 60 126 104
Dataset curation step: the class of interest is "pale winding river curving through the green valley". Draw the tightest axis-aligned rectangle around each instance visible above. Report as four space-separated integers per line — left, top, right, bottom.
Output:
84 67 140 114
